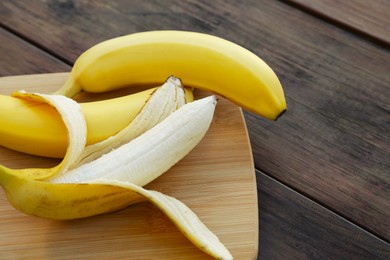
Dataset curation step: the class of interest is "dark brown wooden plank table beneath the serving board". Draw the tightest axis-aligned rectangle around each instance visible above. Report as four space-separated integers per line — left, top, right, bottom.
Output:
0 0 390 259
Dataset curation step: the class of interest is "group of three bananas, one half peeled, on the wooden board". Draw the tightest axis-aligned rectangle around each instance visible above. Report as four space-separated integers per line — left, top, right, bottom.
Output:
0 31 286 259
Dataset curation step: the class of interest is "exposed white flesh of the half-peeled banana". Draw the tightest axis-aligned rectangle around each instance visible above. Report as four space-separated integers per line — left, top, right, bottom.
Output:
50 96 216 186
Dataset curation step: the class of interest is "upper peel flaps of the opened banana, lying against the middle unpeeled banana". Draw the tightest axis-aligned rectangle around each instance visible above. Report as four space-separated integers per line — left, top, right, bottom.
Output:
14 77 185 180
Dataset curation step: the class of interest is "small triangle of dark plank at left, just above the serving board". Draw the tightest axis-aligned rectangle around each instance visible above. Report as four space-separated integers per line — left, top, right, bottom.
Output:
0 28 70 76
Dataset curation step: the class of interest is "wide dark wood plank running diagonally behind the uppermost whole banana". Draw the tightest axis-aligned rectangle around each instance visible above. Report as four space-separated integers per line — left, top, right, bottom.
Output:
0 0 390 247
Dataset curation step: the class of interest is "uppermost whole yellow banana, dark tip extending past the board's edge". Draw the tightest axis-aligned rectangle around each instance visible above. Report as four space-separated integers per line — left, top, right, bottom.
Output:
55 31 287 120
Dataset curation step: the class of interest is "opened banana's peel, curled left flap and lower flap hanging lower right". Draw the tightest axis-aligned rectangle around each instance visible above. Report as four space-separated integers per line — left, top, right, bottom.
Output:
0 87 233 259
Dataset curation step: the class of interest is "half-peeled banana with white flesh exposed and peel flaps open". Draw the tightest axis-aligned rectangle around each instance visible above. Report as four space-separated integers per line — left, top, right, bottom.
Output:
0 88 233 259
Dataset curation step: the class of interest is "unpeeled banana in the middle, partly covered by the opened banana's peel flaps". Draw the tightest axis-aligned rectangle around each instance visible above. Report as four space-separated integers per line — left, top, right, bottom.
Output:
0 77 193 158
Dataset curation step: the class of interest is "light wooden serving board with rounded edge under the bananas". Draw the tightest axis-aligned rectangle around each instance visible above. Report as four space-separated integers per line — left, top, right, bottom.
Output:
0 73 258 259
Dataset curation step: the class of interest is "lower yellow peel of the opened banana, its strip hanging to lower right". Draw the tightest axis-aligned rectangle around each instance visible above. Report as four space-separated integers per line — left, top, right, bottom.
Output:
0 165 233 259
